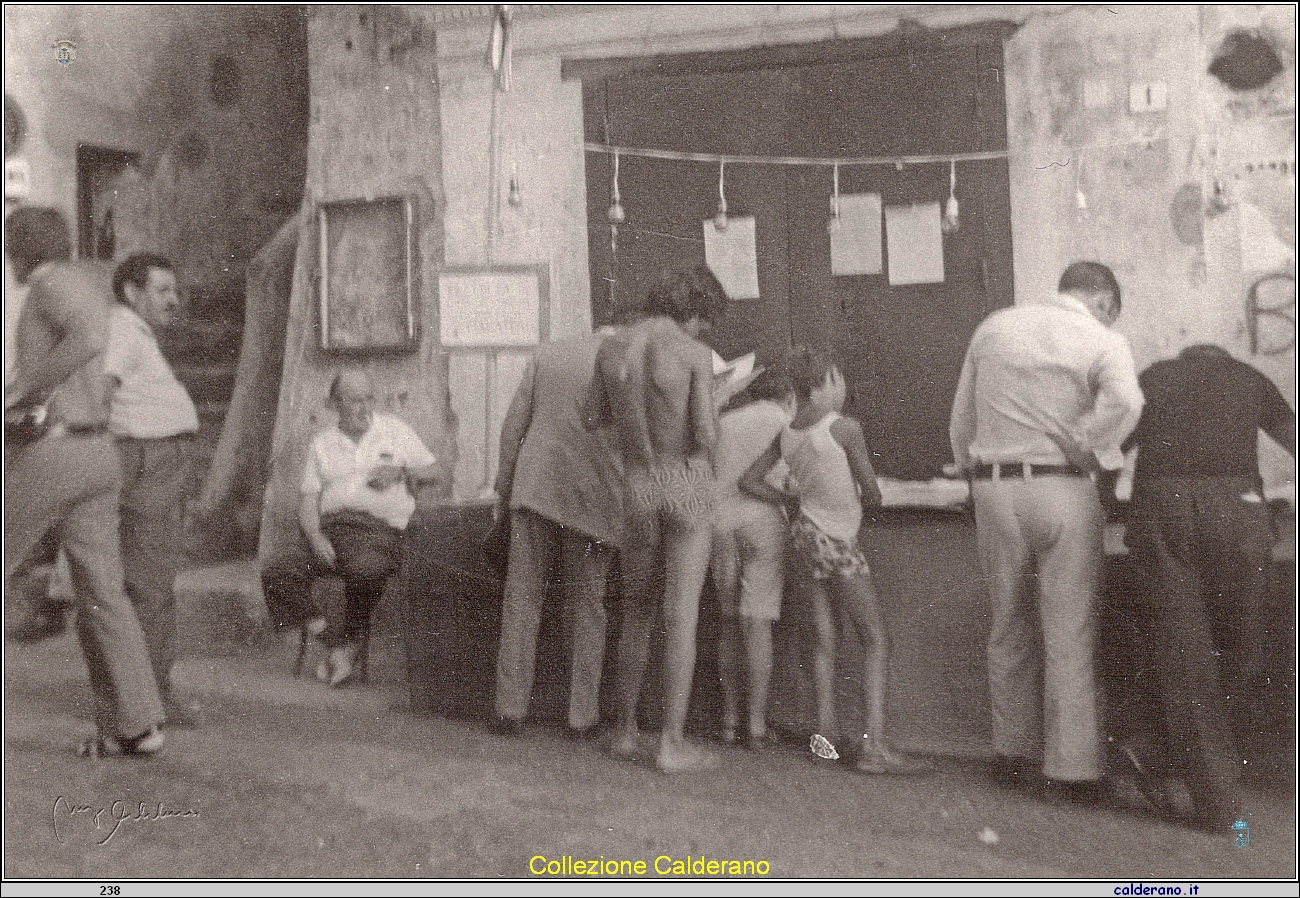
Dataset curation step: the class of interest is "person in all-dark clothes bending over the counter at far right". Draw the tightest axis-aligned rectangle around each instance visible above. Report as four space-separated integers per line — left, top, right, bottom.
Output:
1125 343 1296 833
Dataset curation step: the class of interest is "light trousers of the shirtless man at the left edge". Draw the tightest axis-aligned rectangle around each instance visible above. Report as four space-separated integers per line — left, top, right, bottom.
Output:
4 434 163 738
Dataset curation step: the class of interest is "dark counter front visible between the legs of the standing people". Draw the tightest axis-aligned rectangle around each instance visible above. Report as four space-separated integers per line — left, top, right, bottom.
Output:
400 506 1295 755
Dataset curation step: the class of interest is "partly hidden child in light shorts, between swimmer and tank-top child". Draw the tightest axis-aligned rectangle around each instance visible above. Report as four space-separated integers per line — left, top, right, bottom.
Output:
710 370 794 750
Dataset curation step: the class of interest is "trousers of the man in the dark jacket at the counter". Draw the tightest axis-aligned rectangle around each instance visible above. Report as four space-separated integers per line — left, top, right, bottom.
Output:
497 508 611 729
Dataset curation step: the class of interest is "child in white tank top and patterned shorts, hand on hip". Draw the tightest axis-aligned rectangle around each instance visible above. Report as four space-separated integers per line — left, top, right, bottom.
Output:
741 348 927 773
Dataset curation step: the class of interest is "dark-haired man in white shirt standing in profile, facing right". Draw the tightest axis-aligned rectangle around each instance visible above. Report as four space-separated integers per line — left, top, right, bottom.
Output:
104 252 199 726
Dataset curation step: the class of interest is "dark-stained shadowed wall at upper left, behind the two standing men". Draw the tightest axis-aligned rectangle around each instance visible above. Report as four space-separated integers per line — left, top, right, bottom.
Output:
4 5 307 317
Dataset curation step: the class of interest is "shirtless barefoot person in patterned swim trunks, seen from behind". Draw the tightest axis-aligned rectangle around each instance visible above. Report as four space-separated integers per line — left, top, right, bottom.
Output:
585 265 727 773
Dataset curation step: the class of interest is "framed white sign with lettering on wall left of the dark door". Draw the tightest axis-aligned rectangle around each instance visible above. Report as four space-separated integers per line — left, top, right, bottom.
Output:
438 272 541 346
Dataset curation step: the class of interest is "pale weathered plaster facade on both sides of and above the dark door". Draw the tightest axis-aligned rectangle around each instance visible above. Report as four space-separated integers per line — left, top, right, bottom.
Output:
269 5 1295 527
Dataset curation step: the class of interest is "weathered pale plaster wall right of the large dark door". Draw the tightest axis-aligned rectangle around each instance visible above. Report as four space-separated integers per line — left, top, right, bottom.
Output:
1006 5 1296 493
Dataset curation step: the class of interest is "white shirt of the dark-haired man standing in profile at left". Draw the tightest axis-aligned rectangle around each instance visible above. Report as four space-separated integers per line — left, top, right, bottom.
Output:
104 303 199 439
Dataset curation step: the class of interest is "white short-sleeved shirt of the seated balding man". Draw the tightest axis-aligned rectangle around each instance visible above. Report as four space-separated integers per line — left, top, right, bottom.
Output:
302 413 436 530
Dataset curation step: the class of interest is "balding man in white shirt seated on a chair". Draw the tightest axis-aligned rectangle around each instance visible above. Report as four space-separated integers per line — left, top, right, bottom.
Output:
261 372 438 686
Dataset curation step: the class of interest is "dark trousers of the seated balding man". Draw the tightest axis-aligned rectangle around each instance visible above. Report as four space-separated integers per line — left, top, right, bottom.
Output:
261 511 402 646
